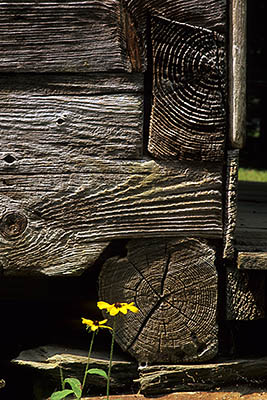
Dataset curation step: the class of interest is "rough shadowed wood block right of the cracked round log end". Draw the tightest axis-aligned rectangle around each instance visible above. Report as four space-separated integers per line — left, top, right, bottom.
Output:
226 268 265 321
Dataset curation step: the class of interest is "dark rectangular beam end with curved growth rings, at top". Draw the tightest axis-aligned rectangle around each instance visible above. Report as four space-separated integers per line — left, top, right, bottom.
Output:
148 17 226 161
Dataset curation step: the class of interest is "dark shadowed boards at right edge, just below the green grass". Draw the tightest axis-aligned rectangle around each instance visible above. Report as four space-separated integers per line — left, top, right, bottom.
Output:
235 181 267 252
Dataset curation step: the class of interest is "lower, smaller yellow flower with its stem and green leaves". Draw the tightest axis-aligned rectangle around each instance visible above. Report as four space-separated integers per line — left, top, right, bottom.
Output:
51 318 112 400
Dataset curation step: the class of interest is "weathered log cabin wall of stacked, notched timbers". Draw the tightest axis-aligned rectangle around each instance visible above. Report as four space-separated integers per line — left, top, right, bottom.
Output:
0 0 264 398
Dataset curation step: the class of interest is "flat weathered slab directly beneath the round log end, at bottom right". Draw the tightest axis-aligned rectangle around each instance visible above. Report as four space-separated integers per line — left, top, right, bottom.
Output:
139 357 267 399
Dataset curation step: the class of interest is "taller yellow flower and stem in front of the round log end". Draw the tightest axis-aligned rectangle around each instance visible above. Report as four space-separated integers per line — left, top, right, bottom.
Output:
97 301 139 400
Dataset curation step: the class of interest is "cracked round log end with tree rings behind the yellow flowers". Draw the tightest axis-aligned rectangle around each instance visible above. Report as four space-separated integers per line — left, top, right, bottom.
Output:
99 239 217 363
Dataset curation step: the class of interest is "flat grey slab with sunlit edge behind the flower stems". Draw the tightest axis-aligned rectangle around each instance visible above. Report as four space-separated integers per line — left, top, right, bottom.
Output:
11 345 138 398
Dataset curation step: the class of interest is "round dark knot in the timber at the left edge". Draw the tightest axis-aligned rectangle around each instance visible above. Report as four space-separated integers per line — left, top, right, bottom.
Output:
0 212 27 240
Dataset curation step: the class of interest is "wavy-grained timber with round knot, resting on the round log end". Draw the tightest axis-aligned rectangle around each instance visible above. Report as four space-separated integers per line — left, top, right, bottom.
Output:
0 159 222 275
